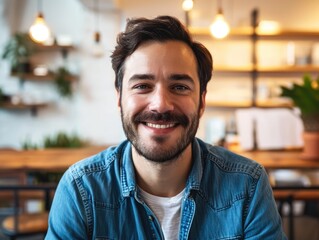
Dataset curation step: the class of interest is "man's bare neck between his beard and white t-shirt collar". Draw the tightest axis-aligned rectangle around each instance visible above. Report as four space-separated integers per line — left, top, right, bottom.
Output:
132 144 192 197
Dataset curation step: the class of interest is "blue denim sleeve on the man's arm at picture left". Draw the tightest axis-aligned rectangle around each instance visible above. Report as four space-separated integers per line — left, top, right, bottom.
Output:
45 171 88 240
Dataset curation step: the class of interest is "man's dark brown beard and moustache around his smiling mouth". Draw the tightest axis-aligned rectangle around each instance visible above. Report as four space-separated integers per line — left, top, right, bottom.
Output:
121 106 199 163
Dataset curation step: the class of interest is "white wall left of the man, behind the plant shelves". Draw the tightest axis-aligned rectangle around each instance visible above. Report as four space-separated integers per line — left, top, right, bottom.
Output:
0 0 123 148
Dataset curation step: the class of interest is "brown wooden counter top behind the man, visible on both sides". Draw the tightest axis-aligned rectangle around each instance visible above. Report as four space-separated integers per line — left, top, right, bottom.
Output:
0 146 319 171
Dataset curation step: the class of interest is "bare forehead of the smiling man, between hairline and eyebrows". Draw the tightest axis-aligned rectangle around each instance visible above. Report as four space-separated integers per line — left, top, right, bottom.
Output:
124 41 197 76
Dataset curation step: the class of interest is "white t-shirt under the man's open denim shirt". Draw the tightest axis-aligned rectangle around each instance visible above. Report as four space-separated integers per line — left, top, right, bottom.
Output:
140 188 185 240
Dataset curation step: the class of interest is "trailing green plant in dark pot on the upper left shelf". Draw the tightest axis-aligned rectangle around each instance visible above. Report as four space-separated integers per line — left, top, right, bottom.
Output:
2 33 36 74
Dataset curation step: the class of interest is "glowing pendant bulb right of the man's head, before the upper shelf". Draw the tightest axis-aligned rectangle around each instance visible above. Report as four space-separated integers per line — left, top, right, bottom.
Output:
210 0 230 39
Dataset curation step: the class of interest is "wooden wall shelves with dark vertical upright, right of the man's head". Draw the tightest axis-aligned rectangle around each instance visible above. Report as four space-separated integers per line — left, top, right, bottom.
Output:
189 9 319 108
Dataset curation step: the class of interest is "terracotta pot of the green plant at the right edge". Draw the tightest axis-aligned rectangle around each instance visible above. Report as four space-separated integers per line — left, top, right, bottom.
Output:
301 131 319 160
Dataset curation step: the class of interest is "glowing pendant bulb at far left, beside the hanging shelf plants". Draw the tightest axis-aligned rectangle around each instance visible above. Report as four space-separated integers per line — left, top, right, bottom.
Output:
29 0 50 43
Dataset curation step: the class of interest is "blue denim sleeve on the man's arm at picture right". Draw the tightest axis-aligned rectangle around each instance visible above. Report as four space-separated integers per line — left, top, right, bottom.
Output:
244 168 287 240
